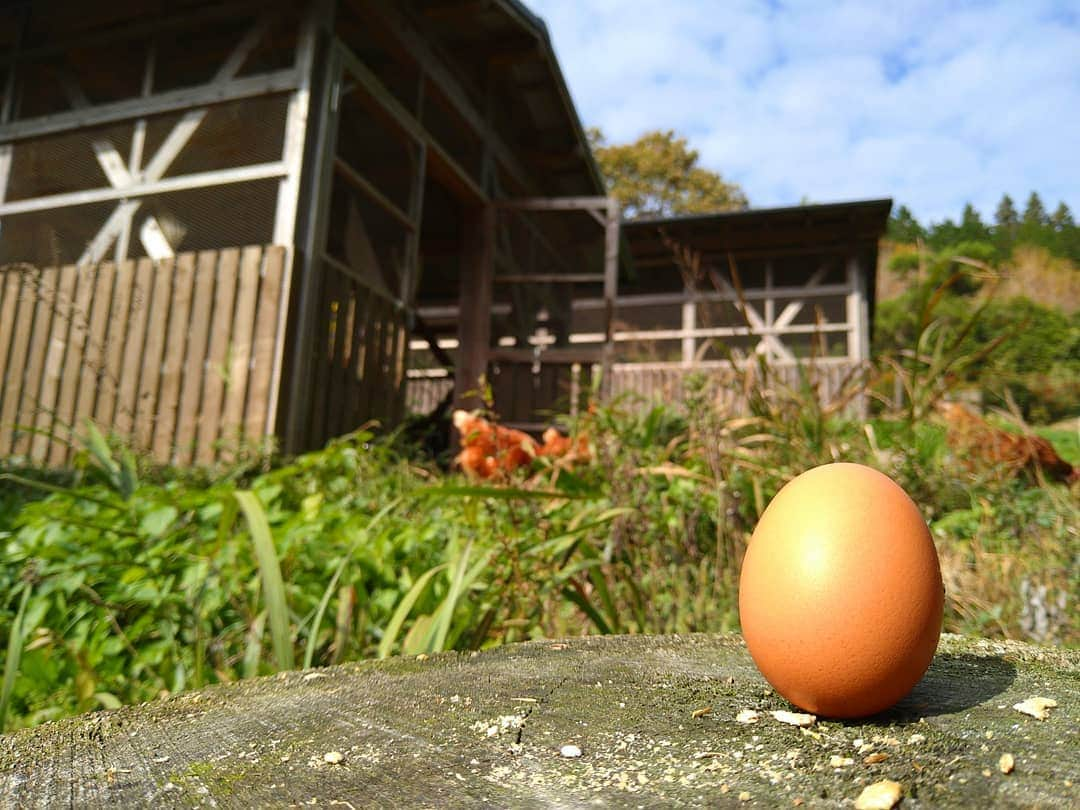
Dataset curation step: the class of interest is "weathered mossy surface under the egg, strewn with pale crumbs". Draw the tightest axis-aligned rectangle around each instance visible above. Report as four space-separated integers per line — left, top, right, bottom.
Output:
0 635 1080 808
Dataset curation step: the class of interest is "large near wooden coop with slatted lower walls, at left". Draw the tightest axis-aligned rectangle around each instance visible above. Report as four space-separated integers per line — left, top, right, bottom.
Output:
0 0 618 464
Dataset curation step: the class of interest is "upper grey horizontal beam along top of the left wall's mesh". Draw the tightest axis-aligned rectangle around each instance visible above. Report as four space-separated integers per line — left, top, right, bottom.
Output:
0 68 300 143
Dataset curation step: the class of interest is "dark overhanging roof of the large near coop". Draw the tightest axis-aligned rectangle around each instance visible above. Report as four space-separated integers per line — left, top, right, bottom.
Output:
0 0 604 197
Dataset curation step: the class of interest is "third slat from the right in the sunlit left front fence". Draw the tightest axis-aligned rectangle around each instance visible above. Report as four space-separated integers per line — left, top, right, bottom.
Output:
195 247 240 464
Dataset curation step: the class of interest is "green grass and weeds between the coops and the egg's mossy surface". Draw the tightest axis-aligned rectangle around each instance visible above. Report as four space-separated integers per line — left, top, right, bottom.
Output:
0 388 1080 729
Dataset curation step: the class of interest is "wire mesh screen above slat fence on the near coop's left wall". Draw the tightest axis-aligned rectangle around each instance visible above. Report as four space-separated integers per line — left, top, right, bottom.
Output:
0 94 288 265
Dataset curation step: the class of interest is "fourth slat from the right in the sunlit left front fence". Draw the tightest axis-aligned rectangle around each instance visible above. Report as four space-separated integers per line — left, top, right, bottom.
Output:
173 251 218 464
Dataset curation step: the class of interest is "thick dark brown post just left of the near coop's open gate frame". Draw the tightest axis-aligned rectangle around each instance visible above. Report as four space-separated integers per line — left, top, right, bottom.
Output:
454 205 495 408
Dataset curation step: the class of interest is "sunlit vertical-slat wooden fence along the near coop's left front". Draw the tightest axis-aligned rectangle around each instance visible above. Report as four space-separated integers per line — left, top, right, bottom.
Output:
0 245 285 465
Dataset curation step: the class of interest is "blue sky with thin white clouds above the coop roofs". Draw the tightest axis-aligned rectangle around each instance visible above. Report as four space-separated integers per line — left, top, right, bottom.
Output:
526 0 1080 221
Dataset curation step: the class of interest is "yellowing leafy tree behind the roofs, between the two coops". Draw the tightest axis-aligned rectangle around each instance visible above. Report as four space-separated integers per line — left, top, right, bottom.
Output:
589 127 747 219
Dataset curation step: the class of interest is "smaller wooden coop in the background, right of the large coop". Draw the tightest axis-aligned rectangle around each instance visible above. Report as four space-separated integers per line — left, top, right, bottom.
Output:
611 200 892 401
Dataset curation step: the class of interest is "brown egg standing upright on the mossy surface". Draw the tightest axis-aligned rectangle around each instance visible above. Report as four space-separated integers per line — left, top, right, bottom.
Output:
739 463 944 717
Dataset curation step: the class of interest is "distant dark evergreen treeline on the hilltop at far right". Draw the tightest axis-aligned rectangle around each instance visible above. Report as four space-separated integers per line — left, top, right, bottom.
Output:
888 191 1080 264
